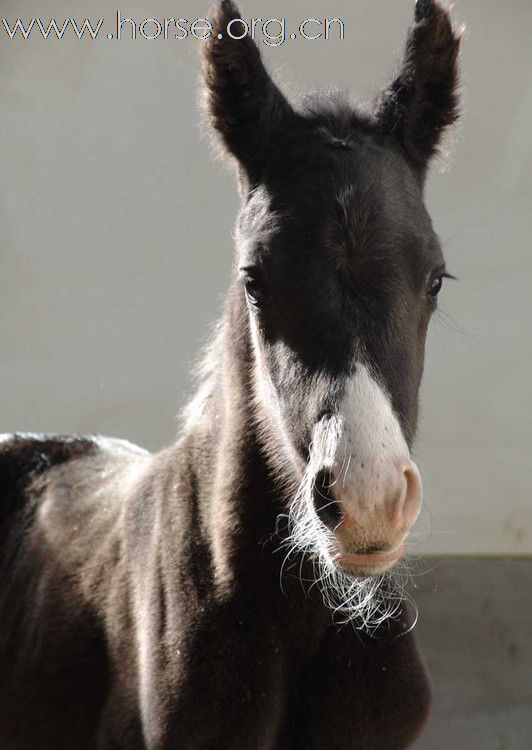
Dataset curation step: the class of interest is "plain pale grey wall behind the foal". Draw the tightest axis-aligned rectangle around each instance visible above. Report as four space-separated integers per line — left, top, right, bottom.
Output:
0 0 532 555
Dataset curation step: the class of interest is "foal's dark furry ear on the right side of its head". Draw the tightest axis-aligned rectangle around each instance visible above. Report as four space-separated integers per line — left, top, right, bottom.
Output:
377 0 460 173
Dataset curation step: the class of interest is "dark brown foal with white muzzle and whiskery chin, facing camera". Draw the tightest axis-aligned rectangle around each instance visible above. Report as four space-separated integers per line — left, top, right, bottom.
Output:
0 0 459 750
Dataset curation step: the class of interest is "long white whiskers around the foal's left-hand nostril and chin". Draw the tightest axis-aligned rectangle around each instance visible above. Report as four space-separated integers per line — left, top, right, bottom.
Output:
280 416 415 630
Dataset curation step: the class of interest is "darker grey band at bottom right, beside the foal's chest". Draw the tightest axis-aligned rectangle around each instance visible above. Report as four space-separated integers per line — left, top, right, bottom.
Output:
413 558 532 750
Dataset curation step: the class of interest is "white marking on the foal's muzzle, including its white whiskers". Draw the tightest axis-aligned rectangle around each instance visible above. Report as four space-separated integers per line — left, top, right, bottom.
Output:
278 363 420 628
